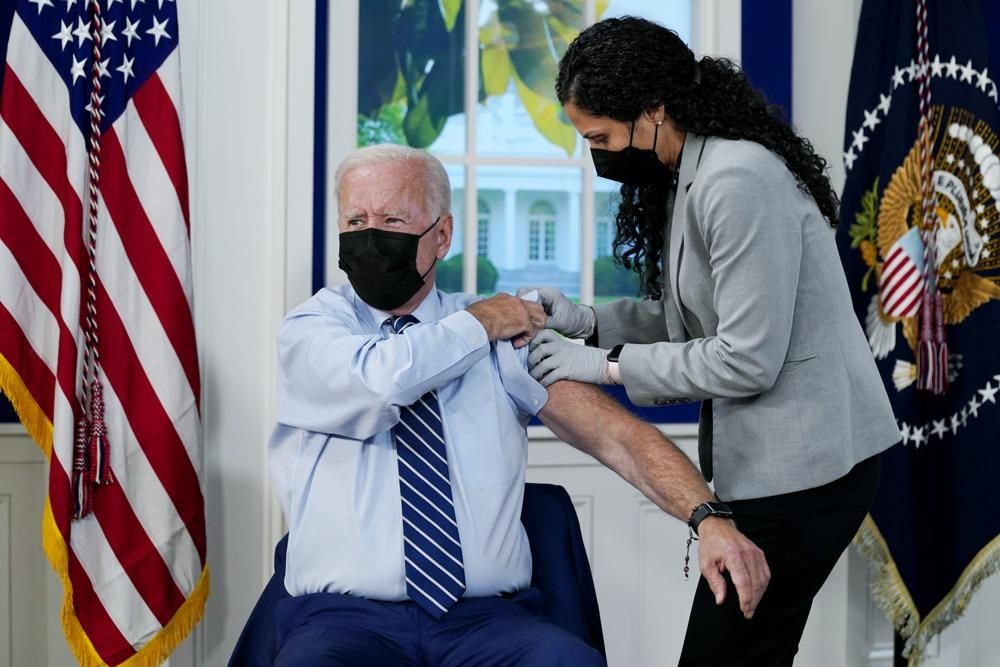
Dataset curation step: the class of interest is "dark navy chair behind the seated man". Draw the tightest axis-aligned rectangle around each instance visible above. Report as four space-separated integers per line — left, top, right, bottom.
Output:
229 484 605 667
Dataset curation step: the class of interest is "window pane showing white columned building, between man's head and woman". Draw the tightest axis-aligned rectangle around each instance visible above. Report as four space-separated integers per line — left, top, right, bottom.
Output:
476 166 582 298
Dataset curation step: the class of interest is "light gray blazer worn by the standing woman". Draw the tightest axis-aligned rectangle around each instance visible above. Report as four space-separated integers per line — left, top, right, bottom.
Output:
594 134 900 500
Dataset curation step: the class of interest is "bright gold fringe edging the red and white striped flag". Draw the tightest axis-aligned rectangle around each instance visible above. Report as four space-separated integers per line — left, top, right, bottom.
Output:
0 355 210 667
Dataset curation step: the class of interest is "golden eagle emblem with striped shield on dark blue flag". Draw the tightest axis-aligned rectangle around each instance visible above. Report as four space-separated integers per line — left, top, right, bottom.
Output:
850 105 1000 390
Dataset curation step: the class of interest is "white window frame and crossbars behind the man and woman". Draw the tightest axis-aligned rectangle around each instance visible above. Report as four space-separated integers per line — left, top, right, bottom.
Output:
326 0 742 303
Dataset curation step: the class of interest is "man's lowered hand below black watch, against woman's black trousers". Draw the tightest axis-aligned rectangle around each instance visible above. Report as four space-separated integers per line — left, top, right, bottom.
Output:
698 516 771 618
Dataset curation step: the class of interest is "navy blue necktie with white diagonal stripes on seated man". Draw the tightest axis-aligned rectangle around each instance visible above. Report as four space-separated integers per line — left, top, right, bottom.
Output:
389 315 465 618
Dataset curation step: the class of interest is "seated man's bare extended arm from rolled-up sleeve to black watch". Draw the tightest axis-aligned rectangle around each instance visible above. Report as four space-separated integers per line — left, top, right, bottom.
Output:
538 381 713 522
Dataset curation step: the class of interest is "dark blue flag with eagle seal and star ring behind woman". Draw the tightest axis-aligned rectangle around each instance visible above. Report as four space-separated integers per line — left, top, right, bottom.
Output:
838 0 1000 662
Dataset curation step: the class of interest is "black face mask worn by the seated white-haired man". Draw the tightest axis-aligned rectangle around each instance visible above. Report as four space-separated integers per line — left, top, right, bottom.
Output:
340 218 441 311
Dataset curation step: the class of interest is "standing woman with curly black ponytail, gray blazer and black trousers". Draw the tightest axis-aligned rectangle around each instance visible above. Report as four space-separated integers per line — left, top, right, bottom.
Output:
529 17 900 667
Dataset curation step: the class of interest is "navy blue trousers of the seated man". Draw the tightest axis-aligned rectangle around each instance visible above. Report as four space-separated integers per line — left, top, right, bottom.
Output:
274 588 606 667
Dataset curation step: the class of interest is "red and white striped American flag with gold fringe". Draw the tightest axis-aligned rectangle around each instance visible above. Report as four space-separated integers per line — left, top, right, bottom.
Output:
0 0 208 665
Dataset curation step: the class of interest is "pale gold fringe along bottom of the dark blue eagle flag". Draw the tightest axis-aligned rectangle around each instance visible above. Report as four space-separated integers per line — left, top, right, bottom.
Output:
854 514 1000 667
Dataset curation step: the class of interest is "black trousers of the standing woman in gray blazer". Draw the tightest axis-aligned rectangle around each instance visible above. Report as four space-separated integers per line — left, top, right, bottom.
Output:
679 456 879 667
